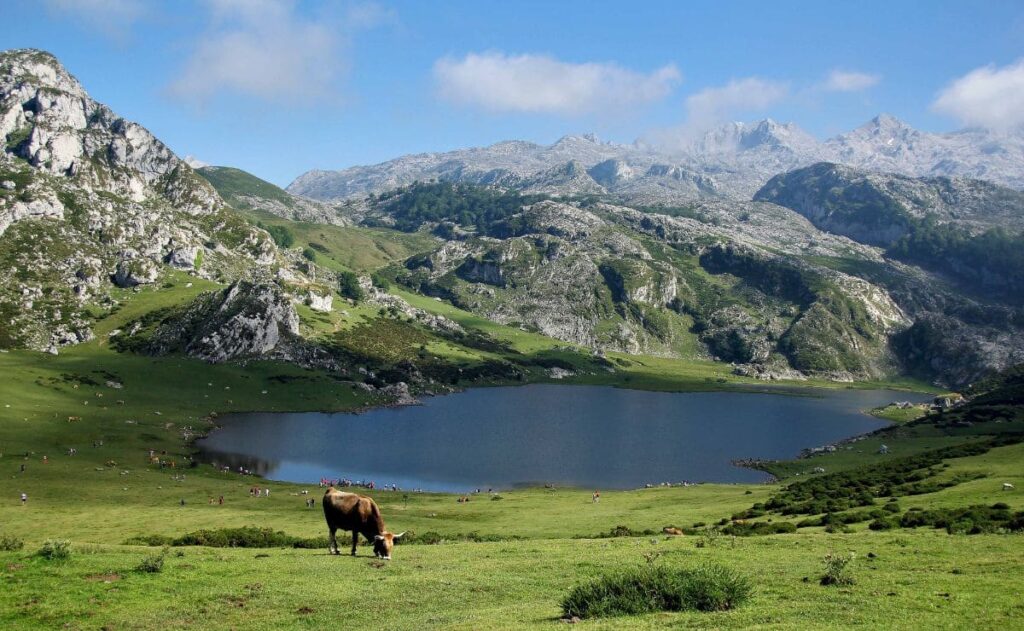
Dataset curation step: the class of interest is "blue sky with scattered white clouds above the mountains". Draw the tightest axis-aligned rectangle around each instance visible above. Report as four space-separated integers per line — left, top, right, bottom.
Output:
0 0 1024 185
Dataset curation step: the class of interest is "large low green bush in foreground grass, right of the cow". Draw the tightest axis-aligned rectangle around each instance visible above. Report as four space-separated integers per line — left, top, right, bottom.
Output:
562 565 754 618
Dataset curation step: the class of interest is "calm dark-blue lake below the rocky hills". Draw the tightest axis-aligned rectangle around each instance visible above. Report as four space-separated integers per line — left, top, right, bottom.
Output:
193 385 930 492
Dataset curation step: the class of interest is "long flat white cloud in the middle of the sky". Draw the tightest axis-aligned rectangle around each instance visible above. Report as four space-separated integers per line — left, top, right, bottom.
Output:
434 52 680 115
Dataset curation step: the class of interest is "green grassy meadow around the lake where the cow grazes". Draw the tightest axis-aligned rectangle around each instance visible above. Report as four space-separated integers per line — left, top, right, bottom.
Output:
0 278 1024 630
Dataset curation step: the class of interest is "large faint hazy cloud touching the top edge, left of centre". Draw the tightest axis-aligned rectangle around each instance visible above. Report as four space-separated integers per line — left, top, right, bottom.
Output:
169 0 347 106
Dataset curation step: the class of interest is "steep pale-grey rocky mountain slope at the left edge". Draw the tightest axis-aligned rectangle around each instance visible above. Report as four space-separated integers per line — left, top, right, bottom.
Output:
0 50 287 352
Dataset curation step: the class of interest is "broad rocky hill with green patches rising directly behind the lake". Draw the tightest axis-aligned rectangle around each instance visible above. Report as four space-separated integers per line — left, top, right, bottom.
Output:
367 184 909 380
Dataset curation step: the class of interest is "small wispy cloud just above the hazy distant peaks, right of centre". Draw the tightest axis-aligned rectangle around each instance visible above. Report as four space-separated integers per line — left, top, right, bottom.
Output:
686 77 790 130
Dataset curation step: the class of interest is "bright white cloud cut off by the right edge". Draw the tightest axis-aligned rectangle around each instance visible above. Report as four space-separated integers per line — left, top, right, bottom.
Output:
932 58 1024 131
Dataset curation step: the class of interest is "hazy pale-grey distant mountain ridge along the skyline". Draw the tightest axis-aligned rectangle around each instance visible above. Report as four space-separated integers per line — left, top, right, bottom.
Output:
288 114 1024 204
